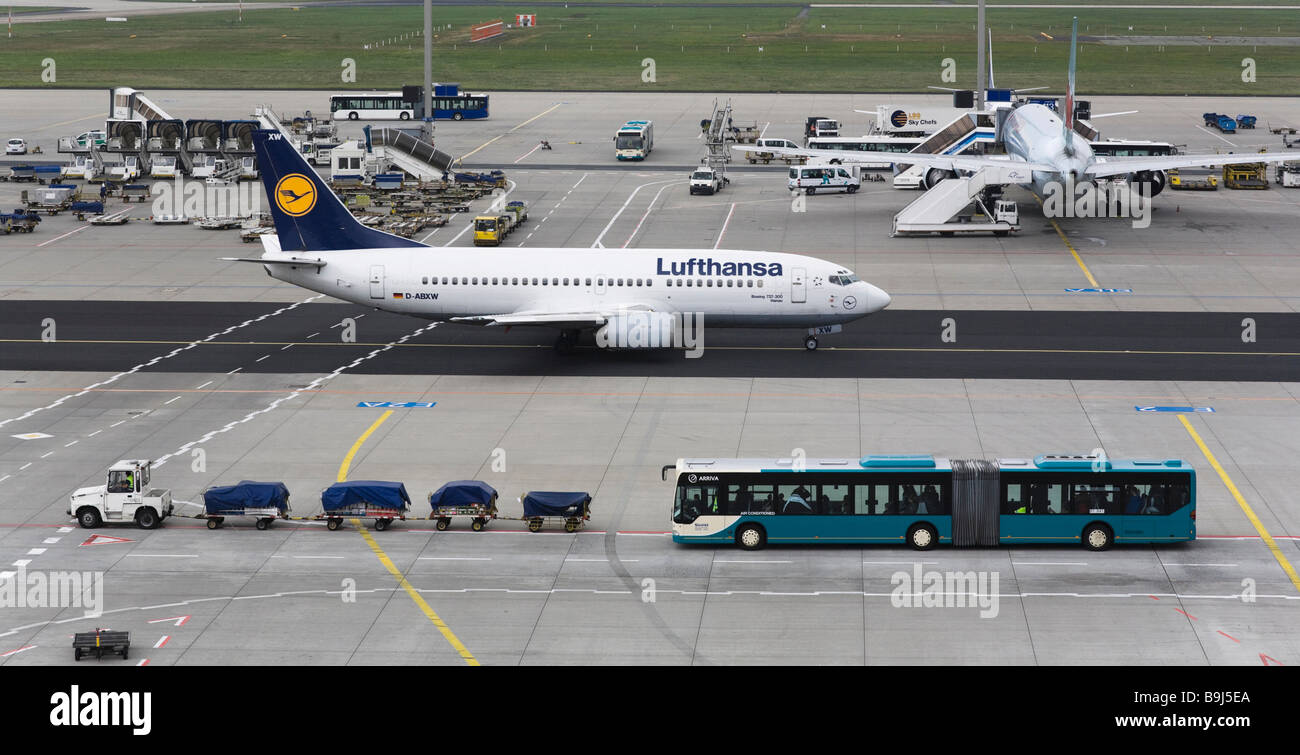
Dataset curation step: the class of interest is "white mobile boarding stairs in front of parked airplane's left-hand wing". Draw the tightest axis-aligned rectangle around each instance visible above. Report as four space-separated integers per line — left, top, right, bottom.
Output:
891 164 1032 237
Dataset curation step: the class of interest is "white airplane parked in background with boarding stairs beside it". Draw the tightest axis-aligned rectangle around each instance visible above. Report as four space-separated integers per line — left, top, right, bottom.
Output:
733 18 1295 202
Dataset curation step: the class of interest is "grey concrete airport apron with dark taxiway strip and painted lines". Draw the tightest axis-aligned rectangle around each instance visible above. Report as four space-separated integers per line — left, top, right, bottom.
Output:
0 91 1300 665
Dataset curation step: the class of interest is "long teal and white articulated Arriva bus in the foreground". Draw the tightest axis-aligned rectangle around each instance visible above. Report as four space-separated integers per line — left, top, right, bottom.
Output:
662 455 1196 551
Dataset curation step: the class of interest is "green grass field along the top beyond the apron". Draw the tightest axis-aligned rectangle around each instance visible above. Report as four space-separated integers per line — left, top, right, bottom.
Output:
0 5 1300 95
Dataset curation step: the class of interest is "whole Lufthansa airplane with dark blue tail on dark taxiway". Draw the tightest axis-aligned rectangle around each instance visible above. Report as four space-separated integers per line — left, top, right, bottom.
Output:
225 130 889 351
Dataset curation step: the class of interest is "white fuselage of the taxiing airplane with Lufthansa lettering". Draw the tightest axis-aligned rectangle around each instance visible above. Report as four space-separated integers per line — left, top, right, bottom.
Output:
265 248 889 327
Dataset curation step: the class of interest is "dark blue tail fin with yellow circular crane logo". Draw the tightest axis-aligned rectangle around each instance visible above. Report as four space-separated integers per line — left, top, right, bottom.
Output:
252 129 425 252
